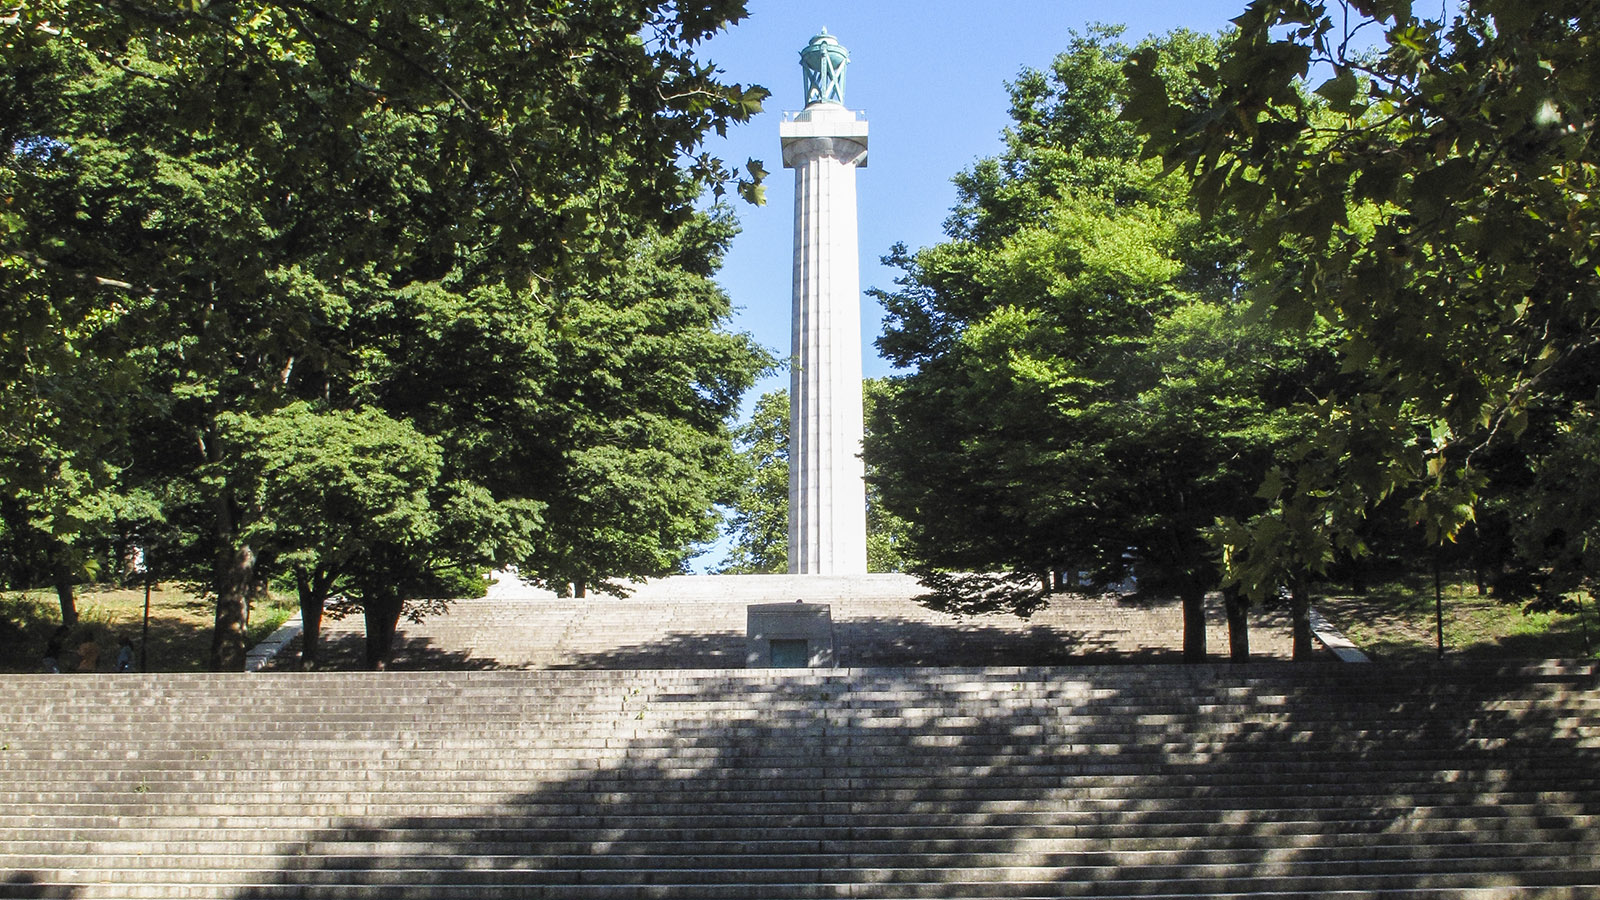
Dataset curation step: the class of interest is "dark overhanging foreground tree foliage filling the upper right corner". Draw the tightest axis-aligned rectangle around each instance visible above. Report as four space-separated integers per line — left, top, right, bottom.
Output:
1128 0 1600 624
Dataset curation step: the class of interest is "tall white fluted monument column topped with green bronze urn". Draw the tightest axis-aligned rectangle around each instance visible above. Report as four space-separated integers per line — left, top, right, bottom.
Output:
779 29 867 575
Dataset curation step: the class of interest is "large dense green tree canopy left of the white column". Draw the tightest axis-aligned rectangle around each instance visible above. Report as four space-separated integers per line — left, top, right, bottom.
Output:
0 0 766 668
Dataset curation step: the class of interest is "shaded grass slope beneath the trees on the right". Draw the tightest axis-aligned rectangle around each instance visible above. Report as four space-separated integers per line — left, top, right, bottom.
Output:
1314 575 1600 661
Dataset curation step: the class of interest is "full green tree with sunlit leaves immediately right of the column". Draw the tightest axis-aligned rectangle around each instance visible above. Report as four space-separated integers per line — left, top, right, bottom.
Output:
869 27 1306 660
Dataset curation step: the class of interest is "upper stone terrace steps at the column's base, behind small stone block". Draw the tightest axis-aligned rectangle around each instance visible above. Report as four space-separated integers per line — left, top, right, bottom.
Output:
274 575 1291 669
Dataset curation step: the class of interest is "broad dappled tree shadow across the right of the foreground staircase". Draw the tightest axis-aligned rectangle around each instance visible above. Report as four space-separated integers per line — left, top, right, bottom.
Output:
200 665 1600 900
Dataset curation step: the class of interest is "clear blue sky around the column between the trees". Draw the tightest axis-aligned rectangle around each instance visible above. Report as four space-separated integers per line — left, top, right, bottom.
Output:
694 0 1246 570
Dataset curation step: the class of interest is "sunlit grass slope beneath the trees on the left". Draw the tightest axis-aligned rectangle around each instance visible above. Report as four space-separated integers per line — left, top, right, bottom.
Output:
0 585 299 673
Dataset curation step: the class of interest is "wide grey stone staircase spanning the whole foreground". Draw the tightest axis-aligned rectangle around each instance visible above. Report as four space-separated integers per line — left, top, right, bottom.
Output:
0 663 1600 900
